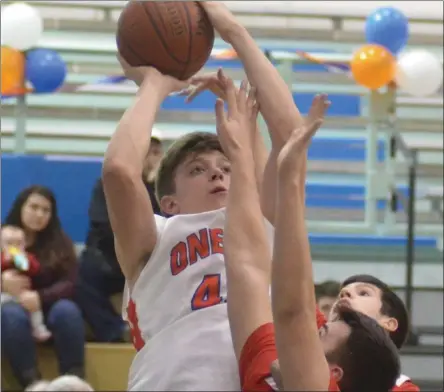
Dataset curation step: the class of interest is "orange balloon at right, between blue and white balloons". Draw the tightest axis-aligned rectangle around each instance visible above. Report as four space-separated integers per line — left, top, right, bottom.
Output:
350 45 396 90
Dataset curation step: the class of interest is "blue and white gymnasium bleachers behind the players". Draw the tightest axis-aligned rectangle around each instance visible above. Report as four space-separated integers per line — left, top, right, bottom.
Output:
1 1 444 390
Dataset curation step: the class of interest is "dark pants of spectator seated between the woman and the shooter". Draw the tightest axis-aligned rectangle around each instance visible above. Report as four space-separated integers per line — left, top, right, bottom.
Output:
75 249 126 342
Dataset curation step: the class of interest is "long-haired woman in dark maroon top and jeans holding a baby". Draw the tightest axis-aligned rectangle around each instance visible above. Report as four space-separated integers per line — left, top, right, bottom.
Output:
1 186 85 388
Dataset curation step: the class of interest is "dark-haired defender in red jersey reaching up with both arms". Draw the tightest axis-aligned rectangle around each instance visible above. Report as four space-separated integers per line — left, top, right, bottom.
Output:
219 89 399 392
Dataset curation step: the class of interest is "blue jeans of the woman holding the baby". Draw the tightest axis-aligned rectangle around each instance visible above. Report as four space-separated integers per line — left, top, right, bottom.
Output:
1 299 85 387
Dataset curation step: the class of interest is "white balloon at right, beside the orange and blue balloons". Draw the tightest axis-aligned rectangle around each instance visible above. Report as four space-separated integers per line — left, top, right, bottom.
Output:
396 50 443 97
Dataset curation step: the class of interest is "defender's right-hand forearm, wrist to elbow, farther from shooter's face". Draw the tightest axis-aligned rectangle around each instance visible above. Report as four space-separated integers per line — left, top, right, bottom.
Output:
272 179 316 320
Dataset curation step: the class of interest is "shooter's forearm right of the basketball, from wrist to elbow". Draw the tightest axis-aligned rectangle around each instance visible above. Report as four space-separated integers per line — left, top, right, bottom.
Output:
230 29 303 146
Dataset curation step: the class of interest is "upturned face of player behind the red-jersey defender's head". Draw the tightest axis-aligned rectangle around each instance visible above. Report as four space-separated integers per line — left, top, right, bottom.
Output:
329 282 398 331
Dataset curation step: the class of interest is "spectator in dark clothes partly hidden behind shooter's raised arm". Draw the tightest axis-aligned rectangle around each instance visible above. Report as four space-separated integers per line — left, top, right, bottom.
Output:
75 137 162 342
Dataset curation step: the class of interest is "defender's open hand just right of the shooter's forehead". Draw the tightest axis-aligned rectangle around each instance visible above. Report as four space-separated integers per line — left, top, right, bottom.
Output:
216 78 259 160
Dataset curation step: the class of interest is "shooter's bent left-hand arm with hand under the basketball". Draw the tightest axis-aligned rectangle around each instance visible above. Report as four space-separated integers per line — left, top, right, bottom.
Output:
102 59 187 282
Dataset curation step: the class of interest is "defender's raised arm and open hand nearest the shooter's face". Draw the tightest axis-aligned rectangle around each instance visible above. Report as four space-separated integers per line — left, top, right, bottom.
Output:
216 80 271 359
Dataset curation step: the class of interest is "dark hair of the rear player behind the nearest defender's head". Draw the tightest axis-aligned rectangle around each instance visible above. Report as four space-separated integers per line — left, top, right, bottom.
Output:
341 275 410 349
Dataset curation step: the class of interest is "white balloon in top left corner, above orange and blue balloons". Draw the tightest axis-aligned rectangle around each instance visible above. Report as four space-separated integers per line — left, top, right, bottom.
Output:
1 3 43 50
